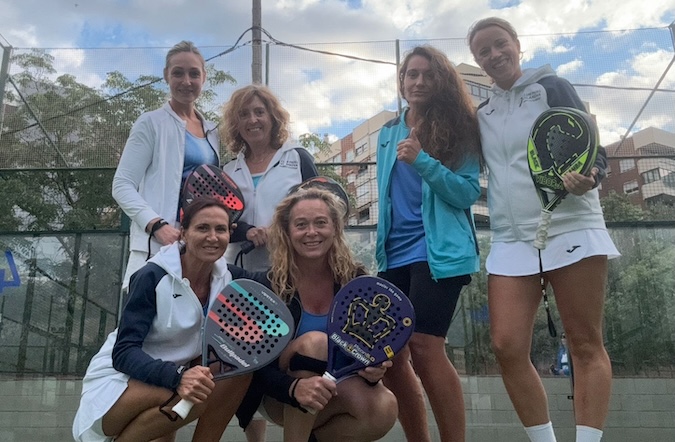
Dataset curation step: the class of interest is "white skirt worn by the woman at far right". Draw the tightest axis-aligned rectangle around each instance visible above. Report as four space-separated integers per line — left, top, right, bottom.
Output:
485 229 621 276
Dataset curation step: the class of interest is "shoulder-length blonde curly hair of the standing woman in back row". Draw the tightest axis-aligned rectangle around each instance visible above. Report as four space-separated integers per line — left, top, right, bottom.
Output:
219 84 291 155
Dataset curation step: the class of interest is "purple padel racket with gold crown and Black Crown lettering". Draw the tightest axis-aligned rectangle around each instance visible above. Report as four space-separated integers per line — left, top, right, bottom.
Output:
309 276 415 413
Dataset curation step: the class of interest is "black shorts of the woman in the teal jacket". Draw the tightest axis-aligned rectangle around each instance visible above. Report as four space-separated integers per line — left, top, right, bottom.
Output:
378 261 471 337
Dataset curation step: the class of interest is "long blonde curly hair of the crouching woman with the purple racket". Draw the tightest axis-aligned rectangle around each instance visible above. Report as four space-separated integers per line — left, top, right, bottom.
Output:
267 188 365 302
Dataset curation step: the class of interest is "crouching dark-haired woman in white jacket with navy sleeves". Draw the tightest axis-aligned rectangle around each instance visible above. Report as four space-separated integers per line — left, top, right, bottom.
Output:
73 198 251 442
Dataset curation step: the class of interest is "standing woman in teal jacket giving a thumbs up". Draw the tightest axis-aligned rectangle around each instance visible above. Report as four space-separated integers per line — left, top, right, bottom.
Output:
376 46 480 441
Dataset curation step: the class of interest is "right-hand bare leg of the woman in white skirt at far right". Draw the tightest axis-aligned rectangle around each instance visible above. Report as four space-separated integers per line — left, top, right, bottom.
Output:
548 256 612 429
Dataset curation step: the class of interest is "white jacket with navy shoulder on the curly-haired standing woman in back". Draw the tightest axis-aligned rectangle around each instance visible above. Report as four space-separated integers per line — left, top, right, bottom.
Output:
223 142 318 272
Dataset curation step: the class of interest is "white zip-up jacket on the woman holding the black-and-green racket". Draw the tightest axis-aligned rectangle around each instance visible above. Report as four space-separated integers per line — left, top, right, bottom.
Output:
478 65 606 242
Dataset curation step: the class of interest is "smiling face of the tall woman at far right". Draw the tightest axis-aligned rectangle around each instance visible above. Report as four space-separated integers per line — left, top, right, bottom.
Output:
470 26 522 90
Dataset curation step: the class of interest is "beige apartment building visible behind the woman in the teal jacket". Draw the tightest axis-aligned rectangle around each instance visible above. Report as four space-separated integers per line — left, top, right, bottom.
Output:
315 63 491 226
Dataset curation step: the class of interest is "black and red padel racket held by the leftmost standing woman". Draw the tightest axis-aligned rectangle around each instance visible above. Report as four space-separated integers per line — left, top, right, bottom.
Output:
181 164 244 223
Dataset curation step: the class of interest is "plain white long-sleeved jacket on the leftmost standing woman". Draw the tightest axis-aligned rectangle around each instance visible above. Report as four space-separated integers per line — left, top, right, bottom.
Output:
112 103 220 255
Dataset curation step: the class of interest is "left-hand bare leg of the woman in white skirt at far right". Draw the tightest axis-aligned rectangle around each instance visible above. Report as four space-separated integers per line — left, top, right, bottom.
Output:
488 275 550 427
